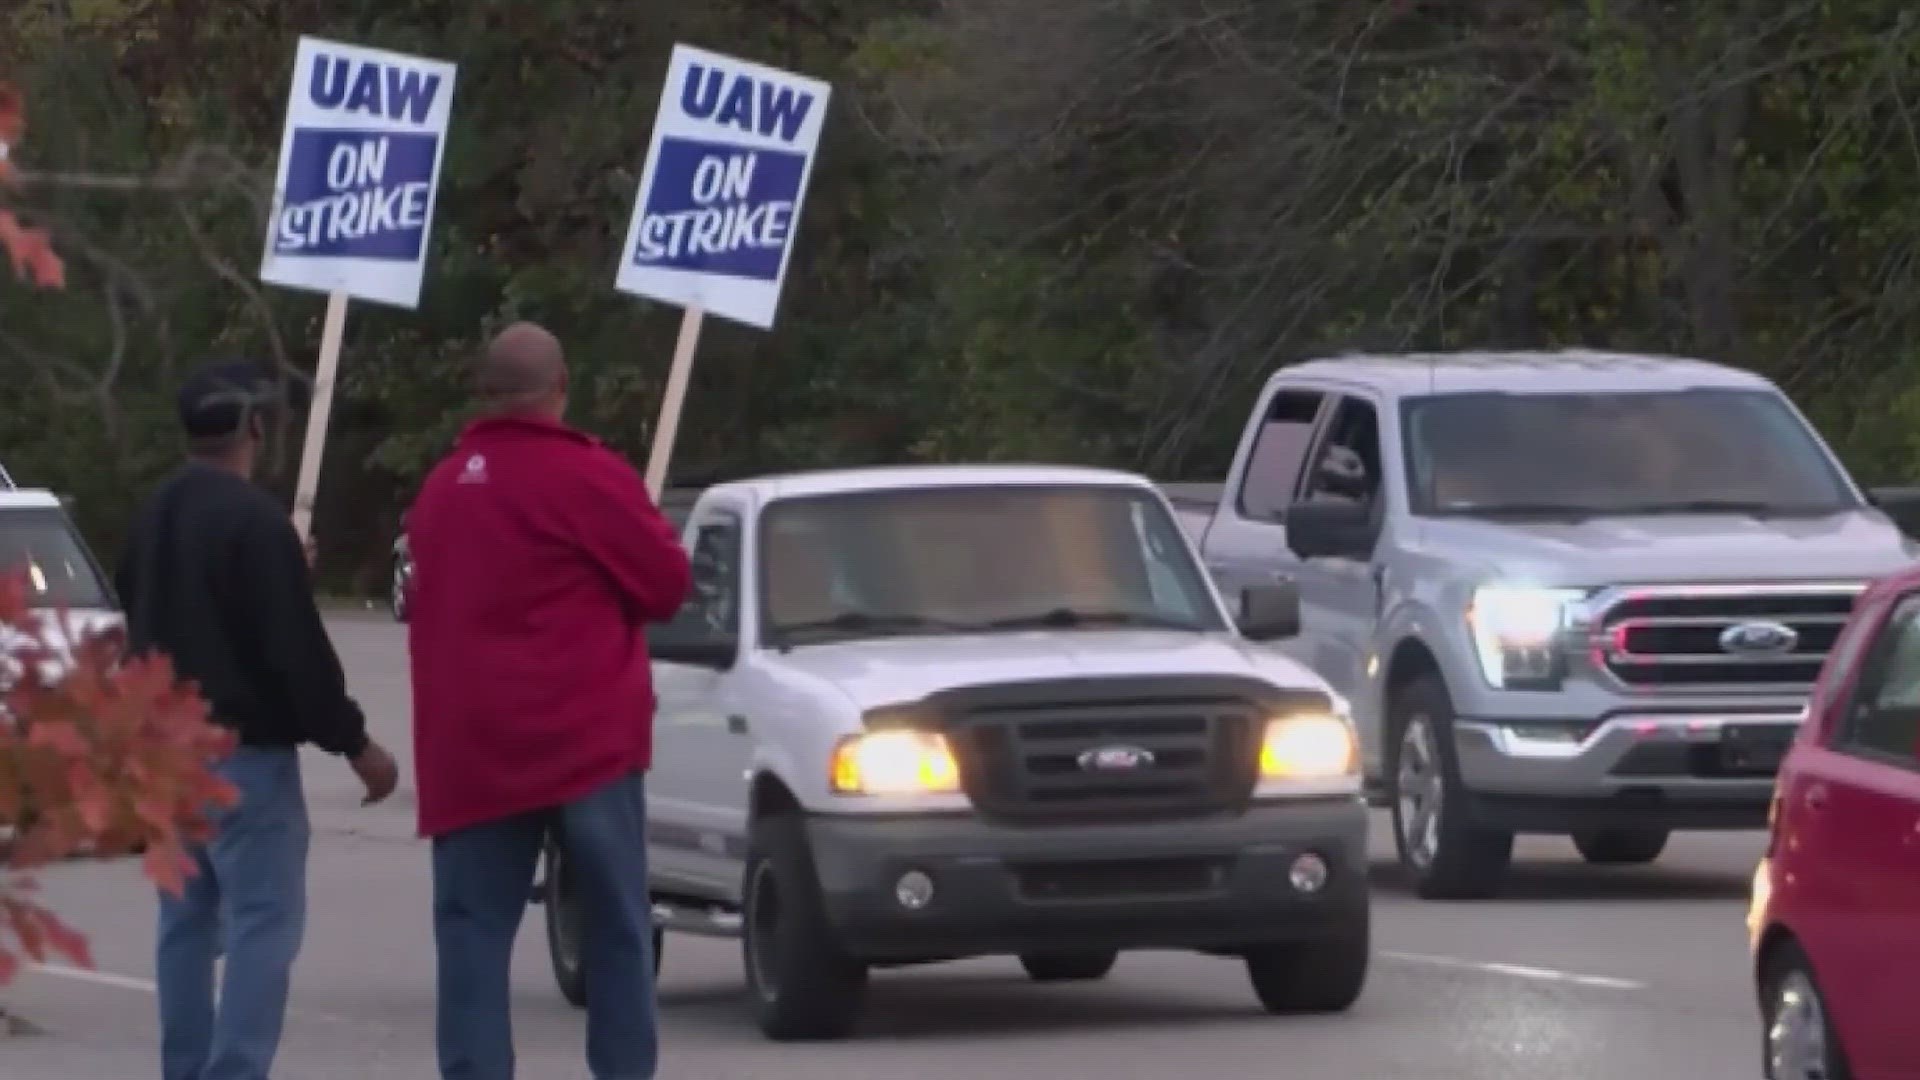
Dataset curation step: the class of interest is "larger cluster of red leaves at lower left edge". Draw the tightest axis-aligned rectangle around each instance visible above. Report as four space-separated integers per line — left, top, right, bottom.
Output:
0 568 238 986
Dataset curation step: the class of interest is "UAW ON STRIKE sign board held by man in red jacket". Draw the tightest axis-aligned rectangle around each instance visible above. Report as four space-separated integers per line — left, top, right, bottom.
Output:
614 44 831 331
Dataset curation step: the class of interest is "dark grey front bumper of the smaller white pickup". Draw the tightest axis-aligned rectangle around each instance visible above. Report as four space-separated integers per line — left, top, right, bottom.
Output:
808 796 1367 961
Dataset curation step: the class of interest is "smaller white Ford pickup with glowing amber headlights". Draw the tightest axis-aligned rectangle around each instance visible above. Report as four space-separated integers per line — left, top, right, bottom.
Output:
540 467 1369 1040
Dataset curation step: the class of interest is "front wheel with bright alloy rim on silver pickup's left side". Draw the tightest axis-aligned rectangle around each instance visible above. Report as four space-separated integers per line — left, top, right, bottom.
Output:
1386 676 1513 899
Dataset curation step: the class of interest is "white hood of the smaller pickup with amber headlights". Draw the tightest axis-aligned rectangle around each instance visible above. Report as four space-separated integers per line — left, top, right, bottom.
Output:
770 630 1327 709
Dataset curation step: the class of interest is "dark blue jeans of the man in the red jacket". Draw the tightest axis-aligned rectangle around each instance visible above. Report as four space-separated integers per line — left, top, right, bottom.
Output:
434 773 659 1080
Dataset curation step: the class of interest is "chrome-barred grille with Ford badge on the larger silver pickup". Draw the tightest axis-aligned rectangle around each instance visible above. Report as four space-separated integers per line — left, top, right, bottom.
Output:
1596 586 1860 692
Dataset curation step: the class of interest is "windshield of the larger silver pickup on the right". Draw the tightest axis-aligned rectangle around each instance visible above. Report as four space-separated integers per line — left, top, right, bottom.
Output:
1402 388 1860 517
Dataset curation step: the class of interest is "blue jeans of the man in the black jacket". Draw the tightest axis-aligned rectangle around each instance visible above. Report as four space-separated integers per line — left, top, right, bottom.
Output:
156 746 313 1080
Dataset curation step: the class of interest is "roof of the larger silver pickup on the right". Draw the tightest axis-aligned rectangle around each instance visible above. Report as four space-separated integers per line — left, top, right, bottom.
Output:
1273 350 1772 398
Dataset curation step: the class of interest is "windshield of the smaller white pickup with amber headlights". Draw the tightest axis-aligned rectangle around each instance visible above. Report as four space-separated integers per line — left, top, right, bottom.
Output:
760 486 1225 646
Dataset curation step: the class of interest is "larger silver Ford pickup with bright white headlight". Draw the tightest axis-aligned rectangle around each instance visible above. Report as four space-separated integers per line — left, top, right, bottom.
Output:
1169 352 1920 899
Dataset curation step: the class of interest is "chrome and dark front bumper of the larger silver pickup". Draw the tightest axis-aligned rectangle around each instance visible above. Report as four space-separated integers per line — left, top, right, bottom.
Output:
1453 711 1801 832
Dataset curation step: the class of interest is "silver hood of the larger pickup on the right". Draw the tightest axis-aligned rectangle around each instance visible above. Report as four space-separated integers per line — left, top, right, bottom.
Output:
1423 511 1920 584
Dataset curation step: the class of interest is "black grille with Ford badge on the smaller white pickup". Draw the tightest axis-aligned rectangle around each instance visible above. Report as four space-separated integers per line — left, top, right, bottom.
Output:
948 684 1267 824
